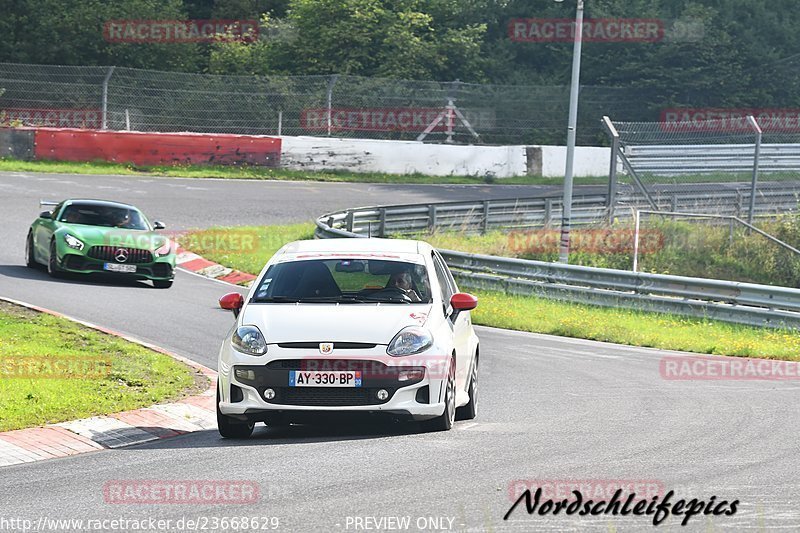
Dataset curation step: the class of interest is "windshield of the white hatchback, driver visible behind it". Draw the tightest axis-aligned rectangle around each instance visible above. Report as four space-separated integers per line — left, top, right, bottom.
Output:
253 258 431 304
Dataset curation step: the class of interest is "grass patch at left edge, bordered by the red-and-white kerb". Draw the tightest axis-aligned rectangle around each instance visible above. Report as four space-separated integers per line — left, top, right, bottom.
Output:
0 302 200 431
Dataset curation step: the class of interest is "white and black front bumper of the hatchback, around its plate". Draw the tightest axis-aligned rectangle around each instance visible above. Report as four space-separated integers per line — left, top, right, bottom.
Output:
219 340 446 421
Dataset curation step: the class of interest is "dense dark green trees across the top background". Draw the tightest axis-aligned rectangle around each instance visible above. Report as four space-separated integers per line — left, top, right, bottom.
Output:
0 0 800 107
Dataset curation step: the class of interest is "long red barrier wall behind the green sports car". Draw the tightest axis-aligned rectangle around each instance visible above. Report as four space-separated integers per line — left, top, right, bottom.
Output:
34 128 281 167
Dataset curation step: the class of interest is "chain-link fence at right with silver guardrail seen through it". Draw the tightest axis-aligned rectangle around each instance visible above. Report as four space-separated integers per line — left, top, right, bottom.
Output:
606 112 800 221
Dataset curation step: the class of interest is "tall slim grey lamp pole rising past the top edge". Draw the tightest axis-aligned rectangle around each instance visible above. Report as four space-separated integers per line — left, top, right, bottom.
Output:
558 0 583 263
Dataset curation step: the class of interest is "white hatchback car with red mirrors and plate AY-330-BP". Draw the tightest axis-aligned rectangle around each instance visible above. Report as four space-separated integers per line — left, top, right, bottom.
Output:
217 239 479 438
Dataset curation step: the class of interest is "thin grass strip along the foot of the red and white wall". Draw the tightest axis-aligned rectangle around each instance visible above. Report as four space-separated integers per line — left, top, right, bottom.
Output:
0 158 608 185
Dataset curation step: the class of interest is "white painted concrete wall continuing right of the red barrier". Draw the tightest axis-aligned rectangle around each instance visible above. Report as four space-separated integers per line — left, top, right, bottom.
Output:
281 136 609 178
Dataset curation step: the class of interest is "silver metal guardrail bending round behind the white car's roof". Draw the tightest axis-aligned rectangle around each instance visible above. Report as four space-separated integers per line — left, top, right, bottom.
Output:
315 198 800 329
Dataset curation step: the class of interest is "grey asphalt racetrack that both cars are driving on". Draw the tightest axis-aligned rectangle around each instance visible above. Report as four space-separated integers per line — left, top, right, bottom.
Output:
0 173 800 531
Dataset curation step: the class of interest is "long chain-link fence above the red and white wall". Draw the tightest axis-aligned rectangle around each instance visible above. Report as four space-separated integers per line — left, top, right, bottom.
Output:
0 63 658 145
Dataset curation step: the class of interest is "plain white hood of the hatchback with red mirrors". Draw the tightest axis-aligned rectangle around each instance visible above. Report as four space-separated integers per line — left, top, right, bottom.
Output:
242 304 431 344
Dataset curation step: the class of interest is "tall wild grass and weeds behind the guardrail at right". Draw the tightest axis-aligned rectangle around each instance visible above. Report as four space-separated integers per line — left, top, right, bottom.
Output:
415 215 800 287
